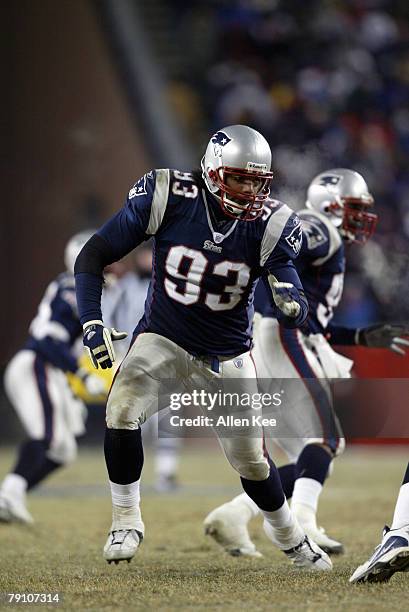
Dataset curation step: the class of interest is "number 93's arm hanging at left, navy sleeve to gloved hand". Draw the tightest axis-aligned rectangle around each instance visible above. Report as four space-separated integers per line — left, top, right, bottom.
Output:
75 170 170 369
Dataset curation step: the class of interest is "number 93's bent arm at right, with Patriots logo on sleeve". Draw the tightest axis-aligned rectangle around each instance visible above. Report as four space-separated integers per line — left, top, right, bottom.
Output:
261 206 308 328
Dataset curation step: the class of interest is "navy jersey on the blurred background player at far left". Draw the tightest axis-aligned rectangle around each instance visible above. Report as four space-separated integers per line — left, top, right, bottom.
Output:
24 273 82 372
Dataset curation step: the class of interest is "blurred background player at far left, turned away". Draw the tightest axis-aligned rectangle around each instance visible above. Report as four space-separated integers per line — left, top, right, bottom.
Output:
0 231 106 523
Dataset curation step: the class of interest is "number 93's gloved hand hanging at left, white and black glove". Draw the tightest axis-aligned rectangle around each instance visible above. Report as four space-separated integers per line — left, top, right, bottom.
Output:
83 321 128 370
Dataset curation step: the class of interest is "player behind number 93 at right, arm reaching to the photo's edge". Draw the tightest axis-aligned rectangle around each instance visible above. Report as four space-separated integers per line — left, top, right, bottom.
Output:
204 168 409 556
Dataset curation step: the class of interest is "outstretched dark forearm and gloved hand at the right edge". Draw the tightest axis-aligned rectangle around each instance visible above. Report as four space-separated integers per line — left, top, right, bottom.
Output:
327 323 409 355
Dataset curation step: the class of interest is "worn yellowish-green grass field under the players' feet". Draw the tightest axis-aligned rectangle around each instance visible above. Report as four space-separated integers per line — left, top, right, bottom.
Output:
0 444 409 612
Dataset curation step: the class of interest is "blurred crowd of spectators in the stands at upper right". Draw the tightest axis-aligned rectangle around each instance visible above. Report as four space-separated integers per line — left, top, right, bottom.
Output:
166 0 409 324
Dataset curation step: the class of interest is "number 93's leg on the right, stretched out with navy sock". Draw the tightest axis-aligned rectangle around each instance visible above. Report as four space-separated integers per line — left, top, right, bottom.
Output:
202 353 331 570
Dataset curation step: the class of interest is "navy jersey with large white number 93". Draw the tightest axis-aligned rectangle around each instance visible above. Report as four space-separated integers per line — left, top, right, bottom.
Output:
76 169 307 355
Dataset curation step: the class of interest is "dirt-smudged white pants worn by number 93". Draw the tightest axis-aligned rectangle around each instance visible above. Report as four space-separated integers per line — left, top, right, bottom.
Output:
106 333 269 480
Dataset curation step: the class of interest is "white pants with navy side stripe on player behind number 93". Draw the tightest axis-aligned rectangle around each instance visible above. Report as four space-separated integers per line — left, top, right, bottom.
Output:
252 317 345 463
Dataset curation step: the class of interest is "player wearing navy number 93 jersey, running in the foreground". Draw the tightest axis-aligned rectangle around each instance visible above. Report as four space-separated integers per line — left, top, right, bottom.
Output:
75 125 331 570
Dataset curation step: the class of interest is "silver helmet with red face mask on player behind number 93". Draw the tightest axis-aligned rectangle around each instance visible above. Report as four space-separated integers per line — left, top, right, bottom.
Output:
306 168 378 244
